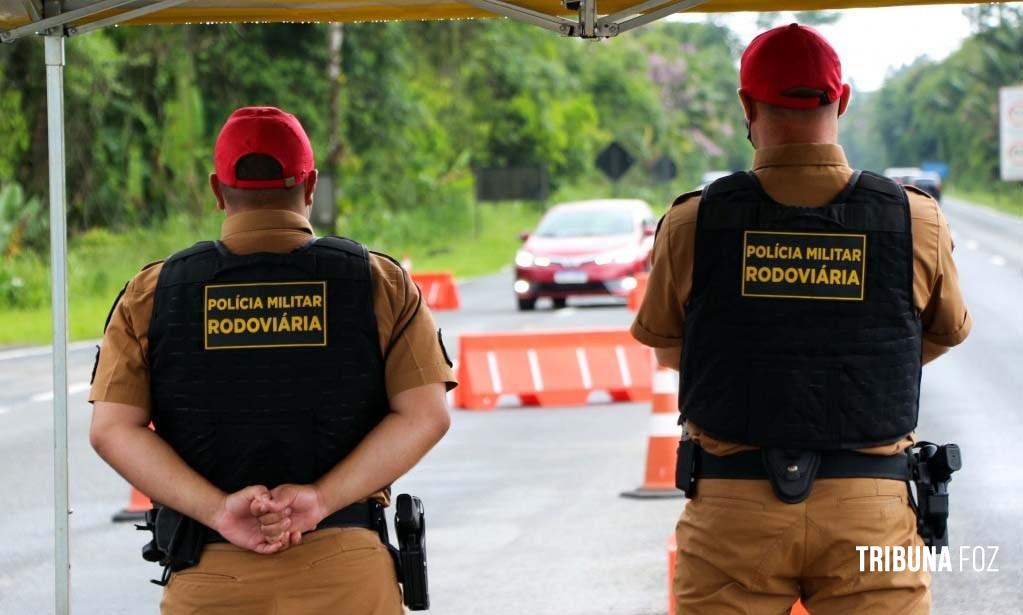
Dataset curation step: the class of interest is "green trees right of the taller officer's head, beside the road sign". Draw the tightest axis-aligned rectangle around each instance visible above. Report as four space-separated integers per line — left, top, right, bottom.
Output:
842 5 1023 214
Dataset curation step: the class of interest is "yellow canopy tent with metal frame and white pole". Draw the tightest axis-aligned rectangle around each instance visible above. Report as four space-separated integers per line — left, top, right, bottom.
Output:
0 0 1002 615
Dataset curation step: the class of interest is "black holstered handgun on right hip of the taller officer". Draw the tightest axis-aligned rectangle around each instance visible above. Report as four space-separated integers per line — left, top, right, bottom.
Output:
909 442 963 548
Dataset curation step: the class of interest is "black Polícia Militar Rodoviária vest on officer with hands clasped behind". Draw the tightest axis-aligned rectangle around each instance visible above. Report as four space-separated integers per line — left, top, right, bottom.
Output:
149 237 388 492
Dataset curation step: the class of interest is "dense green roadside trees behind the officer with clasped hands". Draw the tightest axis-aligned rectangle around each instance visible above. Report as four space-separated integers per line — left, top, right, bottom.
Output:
0 20 746 255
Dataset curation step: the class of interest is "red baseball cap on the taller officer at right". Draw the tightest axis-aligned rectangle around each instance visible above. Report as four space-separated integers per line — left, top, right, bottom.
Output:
739 24 849 108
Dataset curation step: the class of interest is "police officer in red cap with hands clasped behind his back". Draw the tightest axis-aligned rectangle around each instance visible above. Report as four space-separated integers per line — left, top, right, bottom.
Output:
90 107 454 615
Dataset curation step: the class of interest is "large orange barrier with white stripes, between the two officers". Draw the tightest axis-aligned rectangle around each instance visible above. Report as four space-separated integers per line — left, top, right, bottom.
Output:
455 328 654 410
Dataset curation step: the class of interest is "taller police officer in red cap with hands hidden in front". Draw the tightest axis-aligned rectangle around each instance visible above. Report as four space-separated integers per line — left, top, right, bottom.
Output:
632 24 971 615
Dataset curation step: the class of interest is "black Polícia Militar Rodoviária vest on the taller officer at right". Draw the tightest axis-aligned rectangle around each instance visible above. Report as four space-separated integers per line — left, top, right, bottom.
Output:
679 172 922 450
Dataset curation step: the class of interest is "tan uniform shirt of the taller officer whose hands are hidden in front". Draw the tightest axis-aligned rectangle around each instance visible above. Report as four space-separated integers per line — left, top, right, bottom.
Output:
632 143 971 454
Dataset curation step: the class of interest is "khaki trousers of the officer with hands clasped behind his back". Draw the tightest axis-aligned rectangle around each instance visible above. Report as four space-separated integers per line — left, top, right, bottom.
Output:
160 521 404 615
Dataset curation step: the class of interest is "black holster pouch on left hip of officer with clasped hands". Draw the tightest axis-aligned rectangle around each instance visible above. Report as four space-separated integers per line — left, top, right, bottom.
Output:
135 507 206 586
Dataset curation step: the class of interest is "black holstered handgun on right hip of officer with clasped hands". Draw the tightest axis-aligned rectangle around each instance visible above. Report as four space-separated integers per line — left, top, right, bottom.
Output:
394 493 430 611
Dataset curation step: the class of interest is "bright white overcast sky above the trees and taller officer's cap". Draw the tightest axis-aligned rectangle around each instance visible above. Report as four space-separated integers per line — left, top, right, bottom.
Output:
676 4 990 91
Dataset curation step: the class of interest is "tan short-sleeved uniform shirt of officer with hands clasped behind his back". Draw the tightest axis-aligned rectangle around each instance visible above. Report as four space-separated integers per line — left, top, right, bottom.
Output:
89 210 456 500
